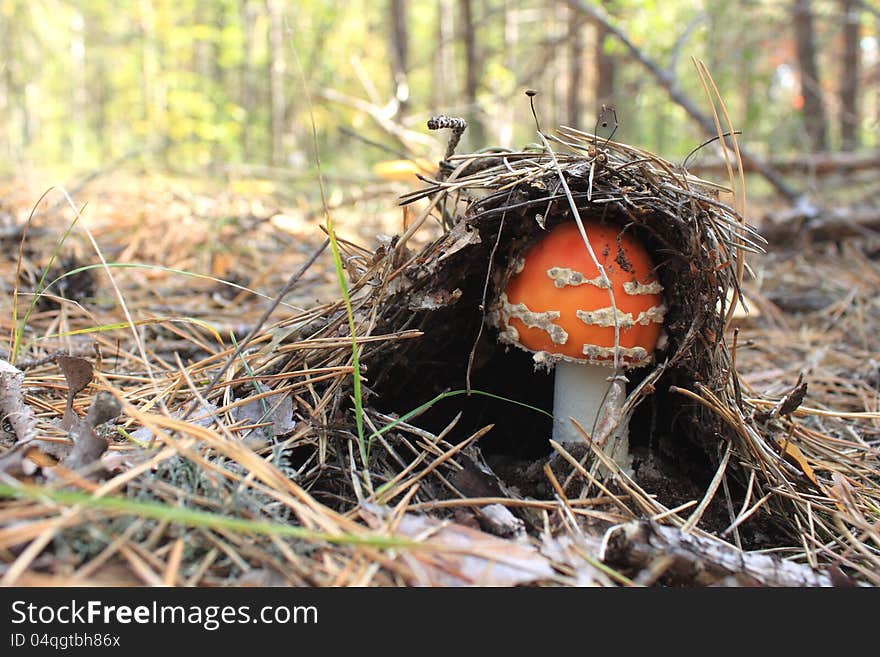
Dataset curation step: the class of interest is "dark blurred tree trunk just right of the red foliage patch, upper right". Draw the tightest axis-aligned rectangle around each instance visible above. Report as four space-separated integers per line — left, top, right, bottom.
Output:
792 0 828 151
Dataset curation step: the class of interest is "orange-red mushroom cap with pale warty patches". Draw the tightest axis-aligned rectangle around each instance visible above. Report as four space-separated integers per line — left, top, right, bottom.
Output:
499 221 666 367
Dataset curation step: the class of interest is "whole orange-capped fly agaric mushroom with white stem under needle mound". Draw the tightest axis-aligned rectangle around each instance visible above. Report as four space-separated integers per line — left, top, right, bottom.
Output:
498 221 666 467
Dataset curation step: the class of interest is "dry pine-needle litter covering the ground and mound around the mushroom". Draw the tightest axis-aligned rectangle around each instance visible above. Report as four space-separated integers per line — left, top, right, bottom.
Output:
0 132 880 586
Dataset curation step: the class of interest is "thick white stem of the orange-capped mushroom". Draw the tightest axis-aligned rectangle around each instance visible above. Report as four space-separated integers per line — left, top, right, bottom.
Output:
553 361 630 470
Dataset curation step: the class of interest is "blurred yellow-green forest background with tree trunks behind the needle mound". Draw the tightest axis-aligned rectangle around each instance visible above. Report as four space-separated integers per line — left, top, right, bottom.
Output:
0 0 880 184
